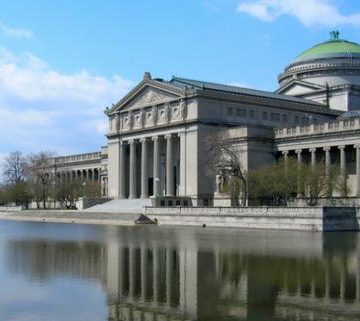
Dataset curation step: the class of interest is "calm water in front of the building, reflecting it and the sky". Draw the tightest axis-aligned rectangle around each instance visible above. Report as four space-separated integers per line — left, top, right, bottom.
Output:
0 221 360 321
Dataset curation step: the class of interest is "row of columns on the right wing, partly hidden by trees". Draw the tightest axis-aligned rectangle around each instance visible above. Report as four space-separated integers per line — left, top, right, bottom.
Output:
282 144 360 197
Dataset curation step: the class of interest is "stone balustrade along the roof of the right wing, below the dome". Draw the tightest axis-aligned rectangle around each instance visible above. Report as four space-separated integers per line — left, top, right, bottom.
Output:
275 118 360 139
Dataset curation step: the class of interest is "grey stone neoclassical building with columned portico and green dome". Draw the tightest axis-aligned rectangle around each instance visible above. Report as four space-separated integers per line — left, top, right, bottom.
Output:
56 32 360 206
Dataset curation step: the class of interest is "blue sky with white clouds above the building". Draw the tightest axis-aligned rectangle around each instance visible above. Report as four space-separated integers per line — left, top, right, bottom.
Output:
0 0 360 158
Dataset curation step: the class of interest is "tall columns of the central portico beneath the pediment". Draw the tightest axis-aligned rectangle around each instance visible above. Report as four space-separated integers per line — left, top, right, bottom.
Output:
118 134 181 199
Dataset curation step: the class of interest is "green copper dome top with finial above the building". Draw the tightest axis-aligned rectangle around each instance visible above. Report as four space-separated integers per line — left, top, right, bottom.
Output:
294 32 360 63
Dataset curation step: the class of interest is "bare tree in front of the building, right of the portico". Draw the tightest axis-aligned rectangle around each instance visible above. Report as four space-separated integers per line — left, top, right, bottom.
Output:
206 128 248 205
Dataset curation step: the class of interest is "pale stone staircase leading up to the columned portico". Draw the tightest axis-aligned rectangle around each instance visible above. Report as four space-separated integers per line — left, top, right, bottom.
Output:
84 198 152 214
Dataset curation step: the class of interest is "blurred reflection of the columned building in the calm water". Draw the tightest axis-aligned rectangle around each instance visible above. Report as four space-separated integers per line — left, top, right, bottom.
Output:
7 227 360 321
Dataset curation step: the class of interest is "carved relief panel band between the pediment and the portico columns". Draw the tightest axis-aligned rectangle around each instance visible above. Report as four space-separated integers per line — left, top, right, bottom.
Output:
110 99 187 134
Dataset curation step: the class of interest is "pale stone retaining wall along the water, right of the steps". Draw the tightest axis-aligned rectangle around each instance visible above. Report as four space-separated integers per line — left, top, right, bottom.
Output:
144 207 360 231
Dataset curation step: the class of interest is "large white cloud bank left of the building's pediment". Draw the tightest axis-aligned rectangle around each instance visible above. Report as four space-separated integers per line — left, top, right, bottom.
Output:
0 48 133 154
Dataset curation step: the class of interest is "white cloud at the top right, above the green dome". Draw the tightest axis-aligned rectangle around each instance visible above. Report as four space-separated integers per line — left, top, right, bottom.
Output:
237 0 360 27
